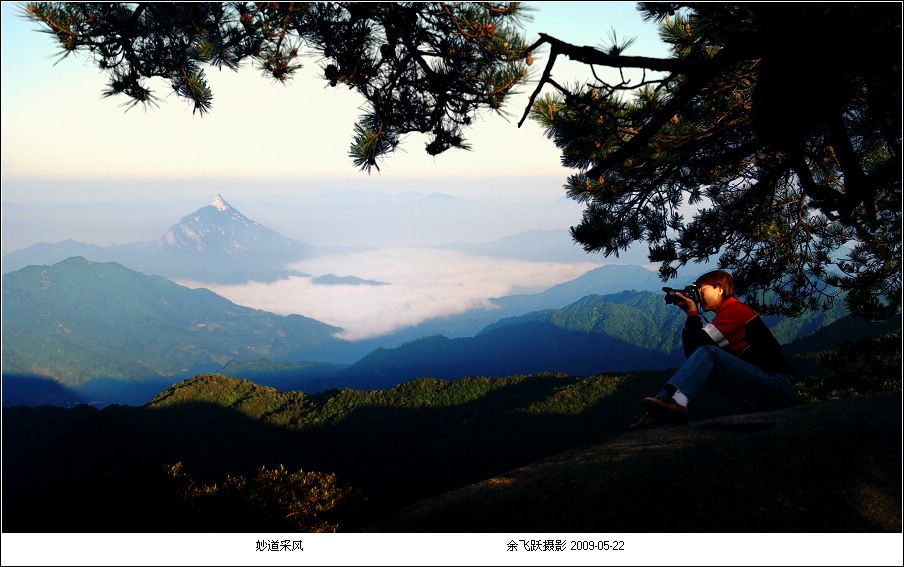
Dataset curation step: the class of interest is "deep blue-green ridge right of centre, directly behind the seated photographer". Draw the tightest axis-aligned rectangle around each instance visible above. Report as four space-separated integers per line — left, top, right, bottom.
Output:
344 288 856 387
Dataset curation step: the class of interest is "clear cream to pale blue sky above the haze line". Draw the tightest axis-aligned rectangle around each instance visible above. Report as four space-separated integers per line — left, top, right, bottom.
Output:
2 2 666 194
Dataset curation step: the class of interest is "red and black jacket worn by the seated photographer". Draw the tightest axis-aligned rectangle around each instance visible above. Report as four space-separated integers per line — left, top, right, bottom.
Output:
681 297 794 374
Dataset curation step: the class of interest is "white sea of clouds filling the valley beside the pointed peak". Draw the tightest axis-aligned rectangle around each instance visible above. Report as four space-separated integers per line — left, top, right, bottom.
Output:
186 248 598 341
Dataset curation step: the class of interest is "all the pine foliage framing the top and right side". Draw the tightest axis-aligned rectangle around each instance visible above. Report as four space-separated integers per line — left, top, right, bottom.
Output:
26 2 902 318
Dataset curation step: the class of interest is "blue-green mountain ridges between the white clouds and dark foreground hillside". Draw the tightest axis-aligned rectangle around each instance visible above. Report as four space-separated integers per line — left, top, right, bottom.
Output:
2 258 869 403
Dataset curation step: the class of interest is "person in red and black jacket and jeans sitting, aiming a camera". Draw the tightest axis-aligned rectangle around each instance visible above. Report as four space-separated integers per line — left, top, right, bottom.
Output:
630 270 795 429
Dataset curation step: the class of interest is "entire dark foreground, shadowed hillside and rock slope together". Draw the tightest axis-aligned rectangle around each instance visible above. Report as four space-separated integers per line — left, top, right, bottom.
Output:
2 373 901 532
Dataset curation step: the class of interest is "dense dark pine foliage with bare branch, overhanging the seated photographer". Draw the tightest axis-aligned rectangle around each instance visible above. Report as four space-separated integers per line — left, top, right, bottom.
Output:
529 2 901 316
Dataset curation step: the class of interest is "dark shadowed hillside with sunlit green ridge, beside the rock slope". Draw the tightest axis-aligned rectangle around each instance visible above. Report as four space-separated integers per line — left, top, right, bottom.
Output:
3 374 676 531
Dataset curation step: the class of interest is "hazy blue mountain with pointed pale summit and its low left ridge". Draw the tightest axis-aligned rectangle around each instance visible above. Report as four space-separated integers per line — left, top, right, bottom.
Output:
3 195 312 284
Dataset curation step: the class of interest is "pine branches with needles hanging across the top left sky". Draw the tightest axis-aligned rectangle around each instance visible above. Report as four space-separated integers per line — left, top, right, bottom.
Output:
26 2 528 171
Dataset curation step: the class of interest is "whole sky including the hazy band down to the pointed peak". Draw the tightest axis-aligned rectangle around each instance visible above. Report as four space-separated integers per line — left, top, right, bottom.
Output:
0 2 667 252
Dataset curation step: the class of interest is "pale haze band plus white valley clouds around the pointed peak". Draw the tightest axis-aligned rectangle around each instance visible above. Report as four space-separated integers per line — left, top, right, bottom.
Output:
3 189 645 341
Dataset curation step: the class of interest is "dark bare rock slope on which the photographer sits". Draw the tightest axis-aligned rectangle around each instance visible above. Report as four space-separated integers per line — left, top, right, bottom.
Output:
367 392 902 533
